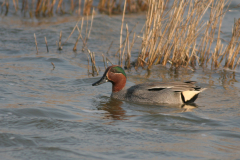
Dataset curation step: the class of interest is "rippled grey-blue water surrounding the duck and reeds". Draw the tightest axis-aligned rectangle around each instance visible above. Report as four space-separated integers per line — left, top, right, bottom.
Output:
0 1 240 160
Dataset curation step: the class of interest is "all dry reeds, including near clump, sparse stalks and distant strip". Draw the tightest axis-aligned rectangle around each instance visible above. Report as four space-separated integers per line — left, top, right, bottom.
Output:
1 0 240 76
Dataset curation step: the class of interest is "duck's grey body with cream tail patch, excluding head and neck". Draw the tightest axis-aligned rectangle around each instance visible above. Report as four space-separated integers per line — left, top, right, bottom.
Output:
112 81 205 104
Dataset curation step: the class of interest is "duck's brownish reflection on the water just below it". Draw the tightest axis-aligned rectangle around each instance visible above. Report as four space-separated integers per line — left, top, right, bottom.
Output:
98 98 197 120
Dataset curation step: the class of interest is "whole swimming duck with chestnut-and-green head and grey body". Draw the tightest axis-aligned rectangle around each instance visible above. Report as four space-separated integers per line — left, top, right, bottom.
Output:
93 66 206 104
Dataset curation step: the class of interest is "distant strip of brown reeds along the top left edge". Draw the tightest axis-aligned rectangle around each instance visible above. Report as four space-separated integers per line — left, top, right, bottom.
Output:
1 0 147 17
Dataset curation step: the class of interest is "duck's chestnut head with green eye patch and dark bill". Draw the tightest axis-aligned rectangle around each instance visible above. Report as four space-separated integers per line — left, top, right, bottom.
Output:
92 65 127 92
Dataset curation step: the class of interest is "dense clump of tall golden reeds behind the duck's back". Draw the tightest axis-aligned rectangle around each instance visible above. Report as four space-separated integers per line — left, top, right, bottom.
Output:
136 0 240 69
